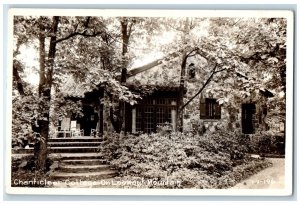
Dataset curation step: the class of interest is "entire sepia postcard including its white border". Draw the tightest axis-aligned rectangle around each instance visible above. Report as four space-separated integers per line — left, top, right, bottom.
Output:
6 9 293 195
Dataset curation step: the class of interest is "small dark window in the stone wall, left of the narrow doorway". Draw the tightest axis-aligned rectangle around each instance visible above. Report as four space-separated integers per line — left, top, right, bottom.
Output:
200 98 221 119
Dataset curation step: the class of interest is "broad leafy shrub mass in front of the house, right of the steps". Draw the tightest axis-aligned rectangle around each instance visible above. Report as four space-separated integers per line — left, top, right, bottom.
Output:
101 129 270 188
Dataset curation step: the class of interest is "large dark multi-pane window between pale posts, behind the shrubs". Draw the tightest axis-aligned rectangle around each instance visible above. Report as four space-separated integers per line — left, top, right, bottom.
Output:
136 97 176 133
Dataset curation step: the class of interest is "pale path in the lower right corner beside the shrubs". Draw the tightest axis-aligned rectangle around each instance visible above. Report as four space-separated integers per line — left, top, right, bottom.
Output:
231 158 285 189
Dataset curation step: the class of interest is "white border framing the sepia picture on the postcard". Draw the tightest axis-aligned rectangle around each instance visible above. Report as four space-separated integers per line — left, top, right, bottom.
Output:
5 9 294 196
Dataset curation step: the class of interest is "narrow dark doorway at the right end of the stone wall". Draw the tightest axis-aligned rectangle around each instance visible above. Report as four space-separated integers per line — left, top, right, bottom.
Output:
242 103 255 134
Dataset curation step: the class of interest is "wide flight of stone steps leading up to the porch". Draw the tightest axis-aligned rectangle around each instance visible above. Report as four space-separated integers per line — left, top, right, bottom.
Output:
48 137 117 187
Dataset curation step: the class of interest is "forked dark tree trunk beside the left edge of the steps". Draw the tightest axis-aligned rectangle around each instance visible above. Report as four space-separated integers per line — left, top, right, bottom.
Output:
35 16 59 171
